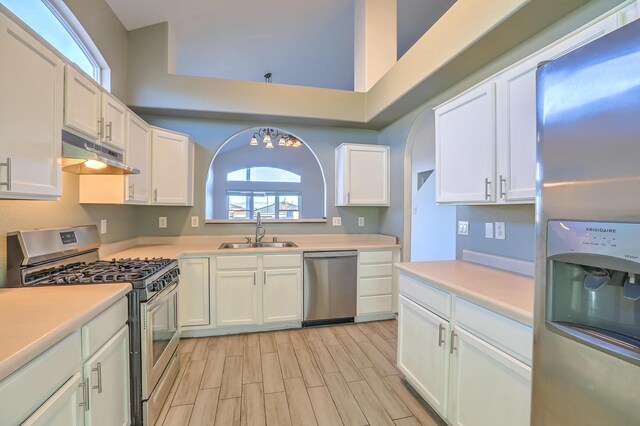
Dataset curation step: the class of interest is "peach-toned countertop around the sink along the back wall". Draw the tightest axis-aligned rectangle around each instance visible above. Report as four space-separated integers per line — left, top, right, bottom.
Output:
100 234 400 259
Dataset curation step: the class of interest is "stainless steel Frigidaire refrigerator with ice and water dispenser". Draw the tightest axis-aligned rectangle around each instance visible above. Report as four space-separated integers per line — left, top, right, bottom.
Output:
532 22 640 426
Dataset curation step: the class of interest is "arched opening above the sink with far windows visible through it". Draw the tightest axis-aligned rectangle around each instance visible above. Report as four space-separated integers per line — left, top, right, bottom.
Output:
206 129 326 221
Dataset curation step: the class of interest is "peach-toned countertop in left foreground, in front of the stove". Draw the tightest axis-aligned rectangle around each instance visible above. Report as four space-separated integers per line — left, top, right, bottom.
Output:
0 284 131 380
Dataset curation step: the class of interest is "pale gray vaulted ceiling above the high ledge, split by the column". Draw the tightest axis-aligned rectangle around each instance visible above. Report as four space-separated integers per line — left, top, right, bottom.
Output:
106 0 454 90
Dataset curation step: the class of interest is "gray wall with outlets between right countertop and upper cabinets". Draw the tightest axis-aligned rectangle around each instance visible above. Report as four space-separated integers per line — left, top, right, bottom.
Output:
454 204 536 261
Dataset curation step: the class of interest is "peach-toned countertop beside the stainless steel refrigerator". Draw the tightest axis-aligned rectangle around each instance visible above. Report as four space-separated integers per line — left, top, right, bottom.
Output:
395 260 534 326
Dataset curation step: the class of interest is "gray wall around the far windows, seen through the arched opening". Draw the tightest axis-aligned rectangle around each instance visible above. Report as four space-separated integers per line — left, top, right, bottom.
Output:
208 129 325 219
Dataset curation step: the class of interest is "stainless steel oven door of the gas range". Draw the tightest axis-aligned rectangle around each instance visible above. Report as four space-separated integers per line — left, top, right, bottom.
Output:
141 280 180 400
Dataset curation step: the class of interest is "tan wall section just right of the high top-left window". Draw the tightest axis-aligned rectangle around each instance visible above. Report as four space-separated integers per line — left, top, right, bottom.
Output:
63 0 128 102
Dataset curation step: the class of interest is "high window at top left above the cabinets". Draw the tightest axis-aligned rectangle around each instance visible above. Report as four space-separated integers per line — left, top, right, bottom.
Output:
0 0 110 90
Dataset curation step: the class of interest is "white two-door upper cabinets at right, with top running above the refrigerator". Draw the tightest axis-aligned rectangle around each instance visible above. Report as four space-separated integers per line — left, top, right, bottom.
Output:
435 7 620 204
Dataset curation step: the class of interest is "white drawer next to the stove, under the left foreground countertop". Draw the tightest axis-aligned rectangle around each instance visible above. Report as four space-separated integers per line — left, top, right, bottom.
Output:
82 298 128 359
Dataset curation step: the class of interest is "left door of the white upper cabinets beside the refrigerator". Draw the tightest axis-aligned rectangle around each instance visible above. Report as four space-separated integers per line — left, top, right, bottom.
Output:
436 81 495 203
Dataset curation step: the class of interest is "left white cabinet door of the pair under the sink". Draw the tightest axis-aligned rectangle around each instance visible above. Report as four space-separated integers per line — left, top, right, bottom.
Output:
216 271 258 326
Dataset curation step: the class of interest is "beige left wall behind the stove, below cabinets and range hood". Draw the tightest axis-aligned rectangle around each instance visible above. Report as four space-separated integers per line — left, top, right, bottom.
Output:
0 172 137 287
